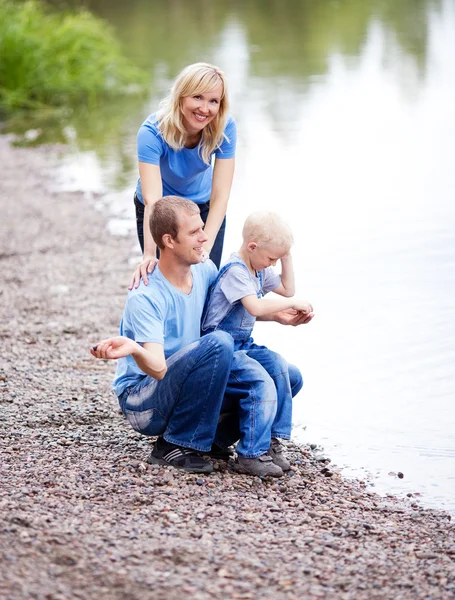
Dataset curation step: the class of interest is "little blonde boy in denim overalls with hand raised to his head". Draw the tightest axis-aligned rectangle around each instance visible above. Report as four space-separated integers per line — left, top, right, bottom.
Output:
202 211 313 477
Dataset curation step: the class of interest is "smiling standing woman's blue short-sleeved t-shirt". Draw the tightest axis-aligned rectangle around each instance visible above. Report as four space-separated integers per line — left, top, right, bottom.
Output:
136 114 237 204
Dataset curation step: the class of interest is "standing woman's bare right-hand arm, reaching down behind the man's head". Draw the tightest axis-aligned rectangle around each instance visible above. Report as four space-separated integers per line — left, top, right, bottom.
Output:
204 158 235 254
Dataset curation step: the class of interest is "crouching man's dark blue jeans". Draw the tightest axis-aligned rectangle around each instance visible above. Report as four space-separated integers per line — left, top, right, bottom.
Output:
119 331 234 452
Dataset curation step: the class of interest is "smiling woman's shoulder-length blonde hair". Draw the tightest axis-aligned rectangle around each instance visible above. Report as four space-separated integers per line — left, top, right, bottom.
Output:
158 63 229 165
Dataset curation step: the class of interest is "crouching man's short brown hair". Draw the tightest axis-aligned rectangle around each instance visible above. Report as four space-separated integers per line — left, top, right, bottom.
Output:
150 196 200 250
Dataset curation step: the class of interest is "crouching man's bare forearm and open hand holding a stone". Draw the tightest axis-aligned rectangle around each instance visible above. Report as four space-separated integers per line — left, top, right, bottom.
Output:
90 336 167 380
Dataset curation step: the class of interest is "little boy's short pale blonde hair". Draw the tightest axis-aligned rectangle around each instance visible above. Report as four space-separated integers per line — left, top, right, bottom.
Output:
242 210 294 249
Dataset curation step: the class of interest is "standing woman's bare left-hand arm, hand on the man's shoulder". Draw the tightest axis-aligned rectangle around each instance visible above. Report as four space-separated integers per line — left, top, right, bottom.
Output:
128 162 163 290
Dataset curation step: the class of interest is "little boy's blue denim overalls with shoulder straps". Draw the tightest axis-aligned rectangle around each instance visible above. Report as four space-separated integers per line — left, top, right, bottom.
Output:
202 261 303 458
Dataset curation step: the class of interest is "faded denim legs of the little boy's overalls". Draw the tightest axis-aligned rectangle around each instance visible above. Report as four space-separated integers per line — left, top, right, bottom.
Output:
217 342 303 458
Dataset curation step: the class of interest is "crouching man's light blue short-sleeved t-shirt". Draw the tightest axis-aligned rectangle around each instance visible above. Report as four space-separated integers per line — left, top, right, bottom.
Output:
114 260 218 396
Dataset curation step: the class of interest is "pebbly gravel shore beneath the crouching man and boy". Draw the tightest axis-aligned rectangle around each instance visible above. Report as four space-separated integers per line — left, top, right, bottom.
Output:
0 137 455 600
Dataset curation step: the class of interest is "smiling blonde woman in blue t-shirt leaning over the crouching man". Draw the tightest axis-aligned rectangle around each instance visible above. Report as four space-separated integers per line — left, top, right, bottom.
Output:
130 63 236 289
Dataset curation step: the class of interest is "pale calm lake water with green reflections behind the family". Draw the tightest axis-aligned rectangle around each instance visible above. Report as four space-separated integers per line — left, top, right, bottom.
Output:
23 0 455 513
